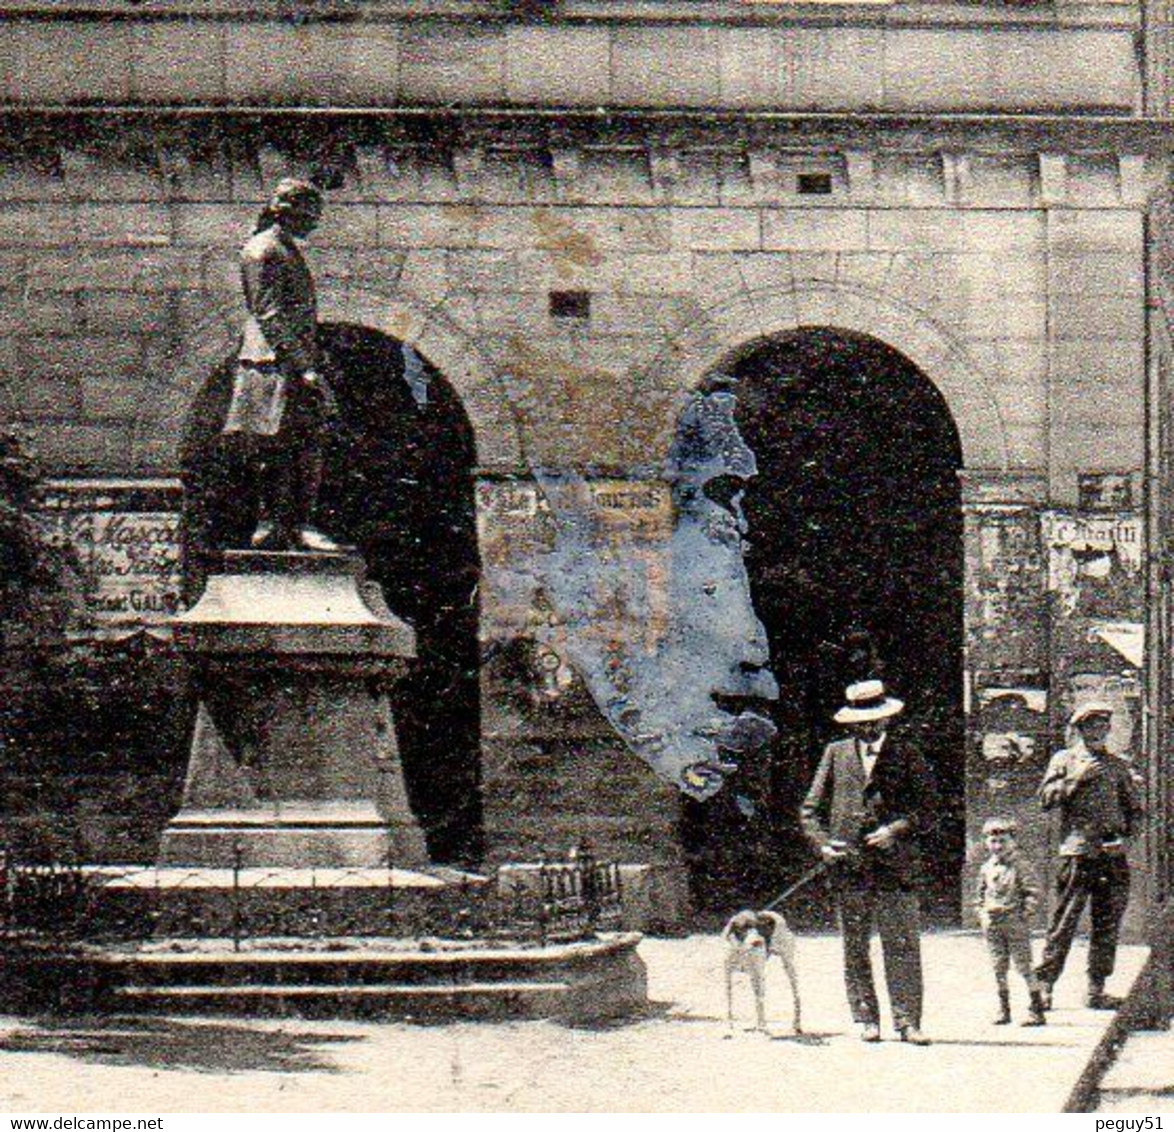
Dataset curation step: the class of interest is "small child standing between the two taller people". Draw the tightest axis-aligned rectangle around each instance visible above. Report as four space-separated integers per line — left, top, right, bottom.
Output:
974 817 1047 1026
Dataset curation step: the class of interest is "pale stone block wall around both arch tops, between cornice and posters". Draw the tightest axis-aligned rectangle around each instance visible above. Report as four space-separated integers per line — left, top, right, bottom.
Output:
0 123 1145 501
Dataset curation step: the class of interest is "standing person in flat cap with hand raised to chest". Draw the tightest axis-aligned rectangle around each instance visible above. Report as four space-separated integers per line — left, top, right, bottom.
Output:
1035 700 1141 1010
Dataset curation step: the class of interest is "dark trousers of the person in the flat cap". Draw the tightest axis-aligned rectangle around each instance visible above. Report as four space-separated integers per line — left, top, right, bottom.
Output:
1035 855 1129 986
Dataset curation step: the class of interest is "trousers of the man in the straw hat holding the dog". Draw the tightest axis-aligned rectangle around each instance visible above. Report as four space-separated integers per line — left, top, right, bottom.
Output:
838 882 923 1030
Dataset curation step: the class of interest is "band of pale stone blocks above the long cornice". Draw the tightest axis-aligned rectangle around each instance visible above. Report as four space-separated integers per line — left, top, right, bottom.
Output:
0 0 1140 113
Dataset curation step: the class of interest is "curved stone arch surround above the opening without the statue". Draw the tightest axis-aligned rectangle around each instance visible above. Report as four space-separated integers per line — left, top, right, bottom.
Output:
645 281 1011 470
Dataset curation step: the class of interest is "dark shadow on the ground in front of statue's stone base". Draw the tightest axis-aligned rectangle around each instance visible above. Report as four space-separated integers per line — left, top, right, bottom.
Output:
0 1018 362 1073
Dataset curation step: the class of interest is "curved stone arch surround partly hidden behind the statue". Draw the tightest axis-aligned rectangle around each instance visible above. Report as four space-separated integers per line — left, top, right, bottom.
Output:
156 285 525 472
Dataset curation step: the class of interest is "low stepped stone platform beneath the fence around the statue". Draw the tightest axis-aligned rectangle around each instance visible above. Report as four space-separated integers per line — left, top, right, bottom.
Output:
4 932 647 1023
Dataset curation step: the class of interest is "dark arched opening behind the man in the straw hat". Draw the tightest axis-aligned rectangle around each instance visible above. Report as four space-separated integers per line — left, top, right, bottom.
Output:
684 329 965 924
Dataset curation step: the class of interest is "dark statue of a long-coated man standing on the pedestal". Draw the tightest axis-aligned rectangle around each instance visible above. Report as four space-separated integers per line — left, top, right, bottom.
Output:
223 177 338 551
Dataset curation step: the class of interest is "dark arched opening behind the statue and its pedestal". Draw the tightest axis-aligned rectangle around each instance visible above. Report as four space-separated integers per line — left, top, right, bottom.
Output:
183 324 483 864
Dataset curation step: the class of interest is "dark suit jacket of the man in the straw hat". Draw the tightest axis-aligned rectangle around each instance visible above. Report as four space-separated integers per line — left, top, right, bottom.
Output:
799 734 938 889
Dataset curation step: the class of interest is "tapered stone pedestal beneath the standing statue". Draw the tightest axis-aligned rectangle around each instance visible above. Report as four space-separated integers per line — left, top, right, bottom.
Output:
160 551 429 869
